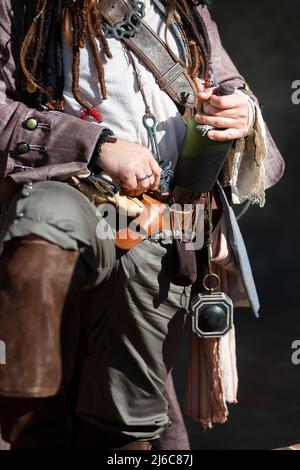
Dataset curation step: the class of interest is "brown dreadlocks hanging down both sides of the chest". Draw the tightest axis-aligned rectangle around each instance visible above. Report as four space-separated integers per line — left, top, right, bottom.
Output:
20 0 211 111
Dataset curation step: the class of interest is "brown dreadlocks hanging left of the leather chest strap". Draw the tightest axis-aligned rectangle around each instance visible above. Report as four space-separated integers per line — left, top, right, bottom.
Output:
20 0 112 111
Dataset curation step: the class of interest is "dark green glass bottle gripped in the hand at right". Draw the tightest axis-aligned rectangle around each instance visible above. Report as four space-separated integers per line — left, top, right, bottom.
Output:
174 85 234 193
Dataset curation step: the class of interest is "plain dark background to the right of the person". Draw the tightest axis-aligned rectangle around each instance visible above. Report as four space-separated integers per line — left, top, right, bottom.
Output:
176 0 300 449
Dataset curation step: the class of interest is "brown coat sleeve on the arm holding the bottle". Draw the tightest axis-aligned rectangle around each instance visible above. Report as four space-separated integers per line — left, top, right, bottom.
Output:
199 6 285 189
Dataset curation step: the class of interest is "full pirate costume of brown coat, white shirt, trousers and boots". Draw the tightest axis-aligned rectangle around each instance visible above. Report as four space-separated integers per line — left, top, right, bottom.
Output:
0 0 284 449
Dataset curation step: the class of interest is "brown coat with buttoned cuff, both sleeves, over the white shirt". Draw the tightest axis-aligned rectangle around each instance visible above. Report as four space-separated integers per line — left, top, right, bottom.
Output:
0 0 284 187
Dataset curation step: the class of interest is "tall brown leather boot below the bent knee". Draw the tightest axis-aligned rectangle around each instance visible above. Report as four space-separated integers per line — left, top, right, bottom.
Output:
0 236 86 447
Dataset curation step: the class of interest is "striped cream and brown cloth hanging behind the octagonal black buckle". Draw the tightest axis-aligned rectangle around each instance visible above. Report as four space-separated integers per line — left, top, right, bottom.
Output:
185 222 238 428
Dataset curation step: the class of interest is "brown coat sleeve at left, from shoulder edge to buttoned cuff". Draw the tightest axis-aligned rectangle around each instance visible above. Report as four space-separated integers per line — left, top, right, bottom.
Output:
0 0 103 184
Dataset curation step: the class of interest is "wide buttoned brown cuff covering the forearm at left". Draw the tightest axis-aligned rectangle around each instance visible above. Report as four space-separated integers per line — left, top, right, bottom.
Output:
0 98 109 184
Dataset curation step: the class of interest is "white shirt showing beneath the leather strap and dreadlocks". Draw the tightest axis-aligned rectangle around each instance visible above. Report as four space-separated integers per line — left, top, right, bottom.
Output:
64 0 185 173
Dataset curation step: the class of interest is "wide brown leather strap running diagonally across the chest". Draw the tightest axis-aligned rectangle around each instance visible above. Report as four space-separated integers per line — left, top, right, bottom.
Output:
99 0 197 108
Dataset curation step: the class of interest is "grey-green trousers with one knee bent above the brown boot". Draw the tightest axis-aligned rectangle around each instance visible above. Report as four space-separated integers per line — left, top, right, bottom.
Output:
0 181 189 439
